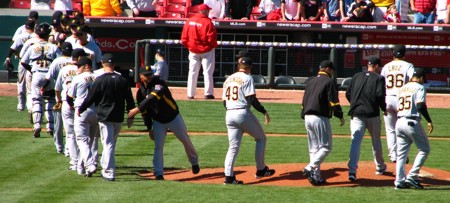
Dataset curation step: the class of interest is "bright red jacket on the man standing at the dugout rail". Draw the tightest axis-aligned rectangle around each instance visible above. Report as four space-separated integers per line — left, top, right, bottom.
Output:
181 14 218 54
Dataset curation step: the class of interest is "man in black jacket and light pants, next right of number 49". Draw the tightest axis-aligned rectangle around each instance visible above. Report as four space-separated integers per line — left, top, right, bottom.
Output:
301 60 345 186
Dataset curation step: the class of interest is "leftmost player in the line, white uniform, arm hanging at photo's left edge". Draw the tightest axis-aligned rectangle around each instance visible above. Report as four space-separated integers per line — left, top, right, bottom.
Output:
5 20 35 111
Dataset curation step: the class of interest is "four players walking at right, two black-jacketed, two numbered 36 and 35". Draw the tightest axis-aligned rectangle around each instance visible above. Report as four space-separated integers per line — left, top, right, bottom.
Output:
301 45 433 189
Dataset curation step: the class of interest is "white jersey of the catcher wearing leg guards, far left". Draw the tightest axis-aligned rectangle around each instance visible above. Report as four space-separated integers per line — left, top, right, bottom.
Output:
21 42 62 72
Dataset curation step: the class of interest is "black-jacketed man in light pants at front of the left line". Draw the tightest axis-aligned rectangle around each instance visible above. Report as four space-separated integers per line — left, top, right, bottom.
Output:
77 54 135 181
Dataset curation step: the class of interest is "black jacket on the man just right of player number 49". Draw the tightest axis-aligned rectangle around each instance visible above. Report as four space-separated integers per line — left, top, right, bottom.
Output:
302 71 344 118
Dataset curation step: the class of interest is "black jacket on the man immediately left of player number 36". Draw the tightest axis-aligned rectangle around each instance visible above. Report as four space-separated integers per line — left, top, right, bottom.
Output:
345 72 386 118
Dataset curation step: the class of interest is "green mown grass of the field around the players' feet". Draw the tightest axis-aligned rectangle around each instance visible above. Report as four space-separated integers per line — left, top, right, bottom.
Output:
0 97 450 202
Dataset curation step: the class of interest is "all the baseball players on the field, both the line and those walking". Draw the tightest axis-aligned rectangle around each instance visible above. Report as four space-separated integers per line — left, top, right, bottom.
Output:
6 11 433 189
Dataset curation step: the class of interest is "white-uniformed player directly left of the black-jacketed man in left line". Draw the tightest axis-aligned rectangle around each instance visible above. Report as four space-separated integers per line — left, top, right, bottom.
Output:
67 56 98 177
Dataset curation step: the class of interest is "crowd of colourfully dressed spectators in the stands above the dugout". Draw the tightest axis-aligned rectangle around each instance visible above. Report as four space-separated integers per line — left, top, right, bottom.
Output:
5 0 450 24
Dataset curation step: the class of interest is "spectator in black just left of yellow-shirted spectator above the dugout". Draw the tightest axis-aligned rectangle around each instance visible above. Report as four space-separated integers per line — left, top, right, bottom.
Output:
347 0 374 22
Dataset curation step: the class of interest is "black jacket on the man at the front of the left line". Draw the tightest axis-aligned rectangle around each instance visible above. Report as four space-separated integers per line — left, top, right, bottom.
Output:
79 73 135 123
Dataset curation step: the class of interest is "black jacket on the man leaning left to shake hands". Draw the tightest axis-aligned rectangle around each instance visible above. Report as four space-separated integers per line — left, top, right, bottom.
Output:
136 77 180 123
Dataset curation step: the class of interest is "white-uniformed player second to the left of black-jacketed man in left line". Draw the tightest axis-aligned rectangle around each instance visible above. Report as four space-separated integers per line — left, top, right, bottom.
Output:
55 49 87 174
